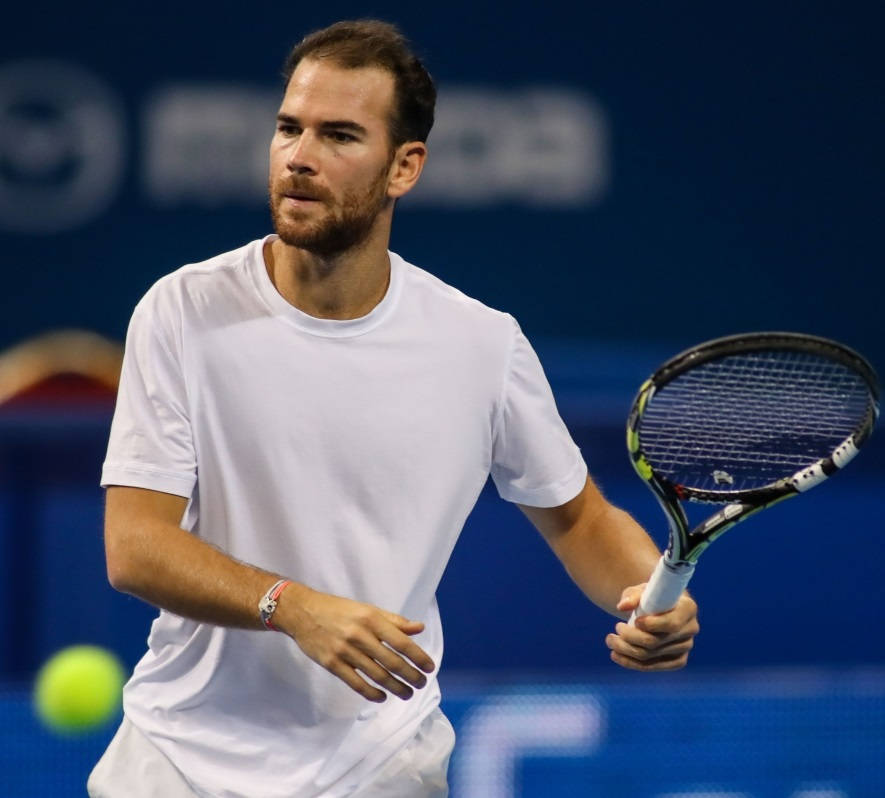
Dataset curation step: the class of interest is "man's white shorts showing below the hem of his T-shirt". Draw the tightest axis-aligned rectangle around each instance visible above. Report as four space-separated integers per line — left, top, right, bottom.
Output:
86 709 455 798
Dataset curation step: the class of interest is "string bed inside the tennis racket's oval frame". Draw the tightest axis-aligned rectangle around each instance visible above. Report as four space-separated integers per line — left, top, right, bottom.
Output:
639 351 871 490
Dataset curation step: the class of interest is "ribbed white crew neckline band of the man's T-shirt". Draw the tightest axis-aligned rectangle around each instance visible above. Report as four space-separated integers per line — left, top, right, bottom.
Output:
248 233 404 338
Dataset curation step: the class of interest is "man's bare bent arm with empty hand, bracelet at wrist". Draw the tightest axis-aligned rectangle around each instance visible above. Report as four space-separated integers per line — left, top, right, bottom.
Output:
105 486 435 702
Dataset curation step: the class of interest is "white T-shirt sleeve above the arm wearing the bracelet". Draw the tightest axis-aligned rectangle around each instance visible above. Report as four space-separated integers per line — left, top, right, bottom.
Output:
101 283 197 498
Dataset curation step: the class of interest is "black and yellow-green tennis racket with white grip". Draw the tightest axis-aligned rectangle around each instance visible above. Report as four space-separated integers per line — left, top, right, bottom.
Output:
627 332 879 624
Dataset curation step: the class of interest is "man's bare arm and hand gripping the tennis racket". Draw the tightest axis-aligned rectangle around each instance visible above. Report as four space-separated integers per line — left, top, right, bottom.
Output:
519 477 699 671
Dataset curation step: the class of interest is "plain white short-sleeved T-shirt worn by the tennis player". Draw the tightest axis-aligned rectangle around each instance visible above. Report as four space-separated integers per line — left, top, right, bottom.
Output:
102 234 587 798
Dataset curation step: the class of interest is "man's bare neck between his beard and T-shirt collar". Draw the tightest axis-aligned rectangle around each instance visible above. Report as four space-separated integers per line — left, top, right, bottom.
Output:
264 238 390 320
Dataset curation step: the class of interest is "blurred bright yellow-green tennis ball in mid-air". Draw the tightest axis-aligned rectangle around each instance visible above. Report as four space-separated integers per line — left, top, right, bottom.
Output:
34 645 124 733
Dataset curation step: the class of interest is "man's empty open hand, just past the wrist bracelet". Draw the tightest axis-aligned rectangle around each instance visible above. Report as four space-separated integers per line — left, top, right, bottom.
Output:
273 582 436 703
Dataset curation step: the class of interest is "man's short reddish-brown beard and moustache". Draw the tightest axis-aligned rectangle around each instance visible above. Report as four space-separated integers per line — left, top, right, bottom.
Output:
269 157 390 258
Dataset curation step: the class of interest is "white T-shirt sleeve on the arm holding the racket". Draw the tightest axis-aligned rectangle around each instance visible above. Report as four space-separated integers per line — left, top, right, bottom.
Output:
491 321 587 507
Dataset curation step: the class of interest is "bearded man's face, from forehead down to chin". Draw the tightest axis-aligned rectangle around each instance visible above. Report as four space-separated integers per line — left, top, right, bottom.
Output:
270 58 394 257
